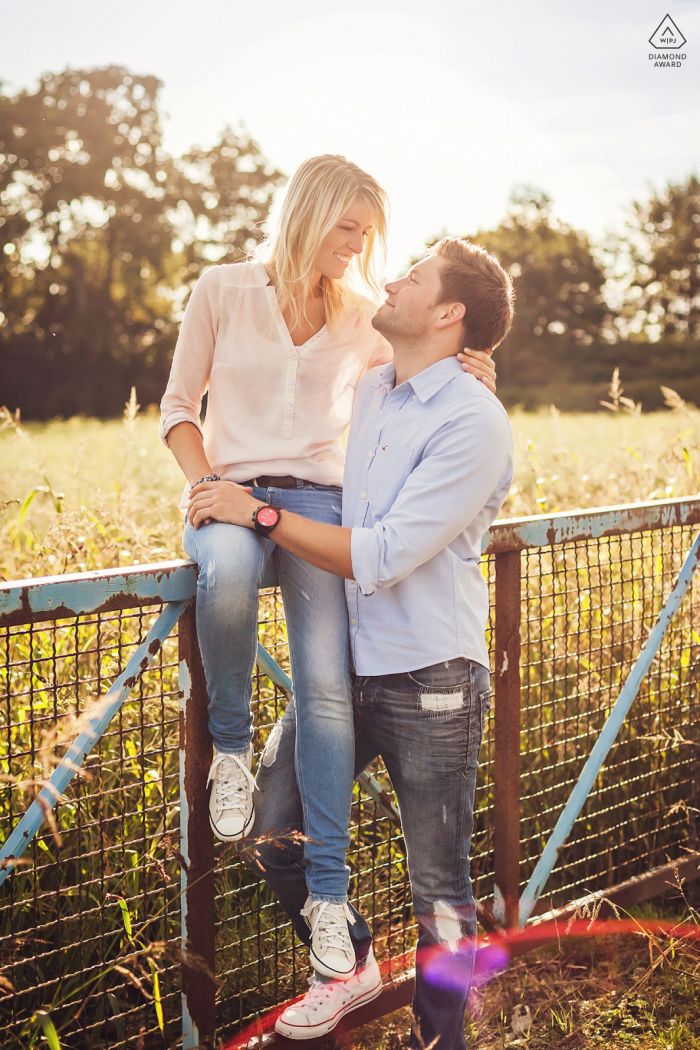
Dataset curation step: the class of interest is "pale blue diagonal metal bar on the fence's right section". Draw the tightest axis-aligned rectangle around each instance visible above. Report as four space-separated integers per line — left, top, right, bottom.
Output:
519 532 700 926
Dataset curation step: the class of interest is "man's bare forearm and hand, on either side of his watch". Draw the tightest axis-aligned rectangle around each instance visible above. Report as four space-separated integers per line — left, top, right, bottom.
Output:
187 481 355 580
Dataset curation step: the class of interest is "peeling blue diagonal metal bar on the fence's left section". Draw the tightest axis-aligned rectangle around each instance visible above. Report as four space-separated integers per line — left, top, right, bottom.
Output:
0 602 189 885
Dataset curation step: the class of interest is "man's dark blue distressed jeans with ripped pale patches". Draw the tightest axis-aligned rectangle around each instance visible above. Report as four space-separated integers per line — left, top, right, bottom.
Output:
246 659 490 1050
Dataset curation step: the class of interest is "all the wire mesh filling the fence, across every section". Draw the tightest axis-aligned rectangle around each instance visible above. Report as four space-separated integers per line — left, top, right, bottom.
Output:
0 503 700 1050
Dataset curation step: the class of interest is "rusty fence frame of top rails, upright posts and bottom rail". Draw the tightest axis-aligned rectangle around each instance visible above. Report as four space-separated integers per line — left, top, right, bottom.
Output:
0 498 700 1050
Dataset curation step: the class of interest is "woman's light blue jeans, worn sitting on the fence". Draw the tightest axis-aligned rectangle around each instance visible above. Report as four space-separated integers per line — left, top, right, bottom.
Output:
183 482 355 902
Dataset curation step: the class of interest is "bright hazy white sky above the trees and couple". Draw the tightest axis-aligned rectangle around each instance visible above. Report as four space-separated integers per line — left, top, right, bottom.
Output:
0 0 700 276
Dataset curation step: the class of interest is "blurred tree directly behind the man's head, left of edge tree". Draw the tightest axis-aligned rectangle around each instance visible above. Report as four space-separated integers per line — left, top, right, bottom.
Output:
470 187 611 386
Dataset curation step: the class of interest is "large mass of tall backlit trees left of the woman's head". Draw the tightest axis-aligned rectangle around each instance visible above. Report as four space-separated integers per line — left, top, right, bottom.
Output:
0 66 282 417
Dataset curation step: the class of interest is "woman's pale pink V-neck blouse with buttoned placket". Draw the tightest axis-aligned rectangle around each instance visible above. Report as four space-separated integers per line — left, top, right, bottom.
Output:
161 263 393 506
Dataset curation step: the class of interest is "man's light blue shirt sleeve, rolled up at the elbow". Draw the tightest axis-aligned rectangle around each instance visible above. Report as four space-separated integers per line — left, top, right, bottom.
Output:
351 399 512 595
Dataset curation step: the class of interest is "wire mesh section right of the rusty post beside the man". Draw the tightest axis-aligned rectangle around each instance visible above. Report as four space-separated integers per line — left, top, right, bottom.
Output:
521 527 700 907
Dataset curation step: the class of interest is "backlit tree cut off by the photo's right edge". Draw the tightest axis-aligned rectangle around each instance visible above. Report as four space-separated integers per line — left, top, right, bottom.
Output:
627 175 700 339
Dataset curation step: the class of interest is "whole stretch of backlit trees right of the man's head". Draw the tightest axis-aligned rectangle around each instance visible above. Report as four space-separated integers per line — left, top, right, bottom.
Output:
421 175 700 403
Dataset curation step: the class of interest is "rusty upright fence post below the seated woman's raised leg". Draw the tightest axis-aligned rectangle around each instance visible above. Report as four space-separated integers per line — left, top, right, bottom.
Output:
178 602 216 1050
